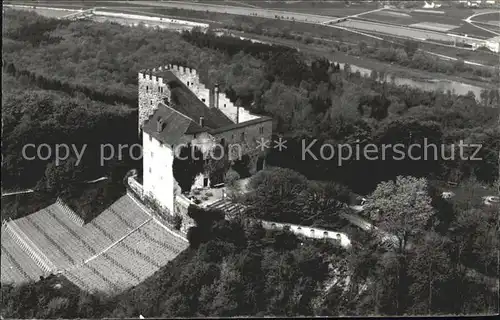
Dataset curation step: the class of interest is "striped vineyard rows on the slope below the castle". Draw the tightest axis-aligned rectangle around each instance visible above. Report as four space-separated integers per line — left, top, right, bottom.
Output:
1 195 188 292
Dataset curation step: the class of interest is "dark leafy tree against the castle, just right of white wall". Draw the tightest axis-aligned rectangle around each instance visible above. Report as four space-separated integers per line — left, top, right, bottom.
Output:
172 144 204 192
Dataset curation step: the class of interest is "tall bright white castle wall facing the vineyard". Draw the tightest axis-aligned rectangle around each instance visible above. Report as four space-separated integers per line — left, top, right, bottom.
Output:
142 132 176 214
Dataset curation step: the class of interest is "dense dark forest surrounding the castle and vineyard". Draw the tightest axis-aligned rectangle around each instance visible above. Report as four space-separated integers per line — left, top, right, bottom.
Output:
1 10 500 318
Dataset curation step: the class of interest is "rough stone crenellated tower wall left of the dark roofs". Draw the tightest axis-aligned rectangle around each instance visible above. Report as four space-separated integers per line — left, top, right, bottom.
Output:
138 72 170 132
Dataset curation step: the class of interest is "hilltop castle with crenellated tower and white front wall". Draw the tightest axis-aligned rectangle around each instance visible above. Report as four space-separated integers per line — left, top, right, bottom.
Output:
132 64 272 214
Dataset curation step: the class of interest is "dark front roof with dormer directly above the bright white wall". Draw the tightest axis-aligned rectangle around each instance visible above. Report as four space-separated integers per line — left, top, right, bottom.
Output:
143 103 202 145
